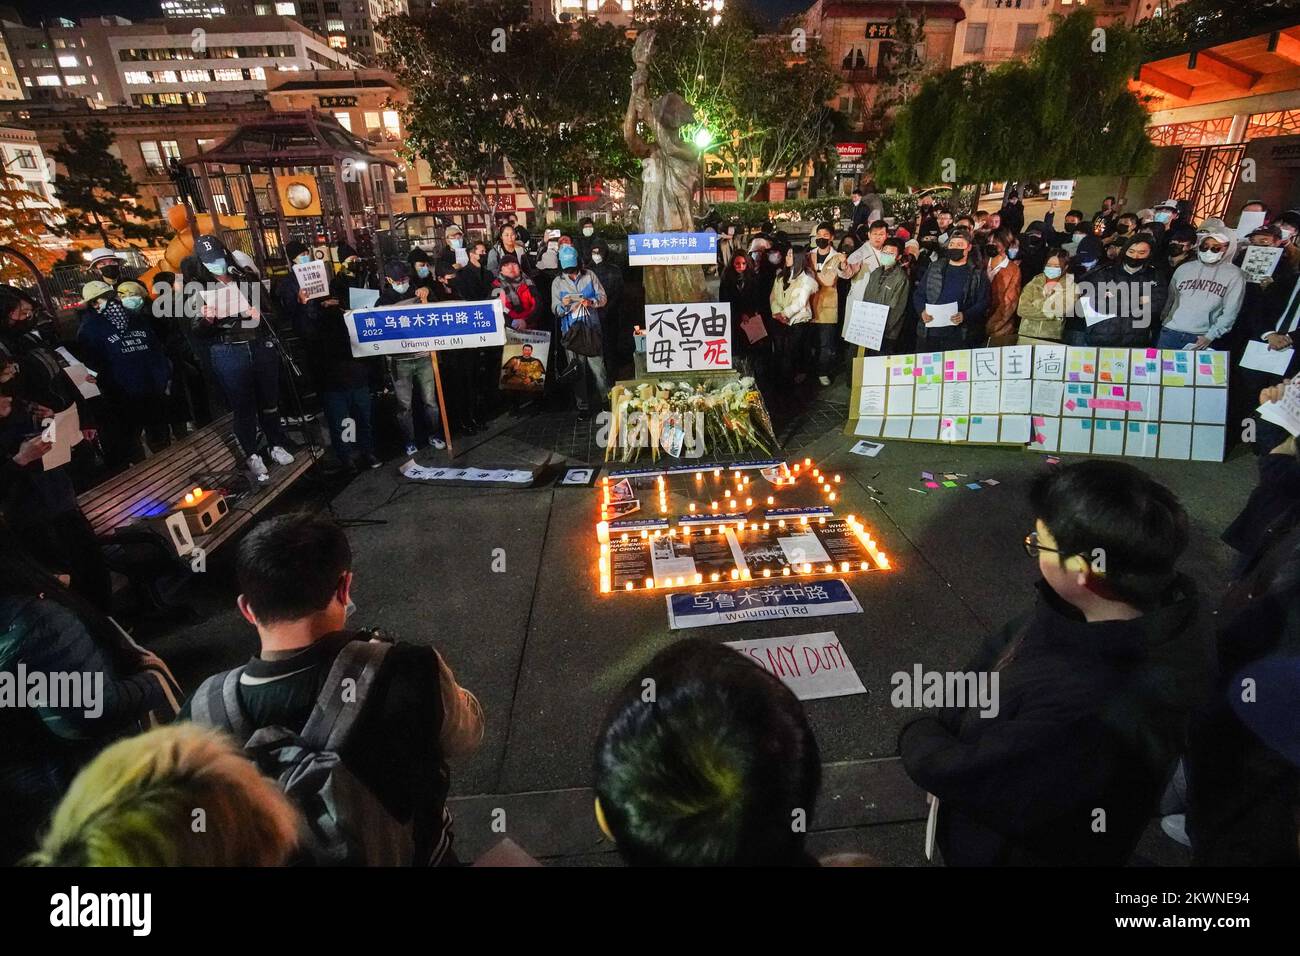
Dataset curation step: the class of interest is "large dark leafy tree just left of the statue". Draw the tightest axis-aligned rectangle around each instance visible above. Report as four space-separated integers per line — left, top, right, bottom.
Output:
380 0 632 222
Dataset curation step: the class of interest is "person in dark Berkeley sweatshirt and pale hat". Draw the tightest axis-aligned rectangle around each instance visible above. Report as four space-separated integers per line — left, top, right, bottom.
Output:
77 280 172 471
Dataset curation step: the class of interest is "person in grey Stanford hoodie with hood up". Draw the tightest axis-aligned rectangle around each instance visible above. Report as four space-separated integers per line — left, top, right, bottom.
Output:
1156 219 1245 350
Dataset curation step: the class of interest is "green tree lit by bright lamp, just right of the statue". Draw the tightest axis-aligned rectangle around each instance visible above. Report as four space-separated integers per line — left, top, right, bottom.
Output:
646 0 841 202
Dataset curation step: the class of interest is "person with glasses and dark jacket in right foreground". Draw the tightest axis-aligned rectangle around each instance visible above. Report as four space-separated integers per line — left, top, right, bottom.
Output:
898 459 1210 866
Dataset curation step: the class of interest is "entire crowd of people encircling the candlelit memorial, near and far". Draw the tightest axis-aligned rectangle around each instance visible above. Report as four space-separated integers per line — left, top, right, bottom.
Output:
0 193 1300 866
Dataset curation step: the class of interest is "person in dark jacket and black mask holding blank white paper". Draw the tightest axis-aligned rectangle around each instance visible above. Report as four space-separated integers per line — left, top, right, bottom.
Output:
911 229 989 351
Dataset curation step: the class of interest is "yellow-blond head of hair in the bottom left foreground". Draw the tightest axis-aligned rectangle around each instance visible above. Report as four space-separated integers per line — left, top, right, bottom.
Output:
26 723 300 866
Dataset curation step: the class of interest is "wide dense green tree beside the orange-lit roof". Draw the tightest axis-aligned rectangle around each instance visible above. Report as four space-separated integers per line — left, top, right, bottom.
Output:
876 9 1154 193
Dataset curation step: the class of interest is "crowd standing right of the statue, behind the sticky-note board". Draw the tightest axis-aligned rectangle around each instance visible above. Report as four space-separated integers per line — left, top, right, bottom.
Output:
719 195 1300 429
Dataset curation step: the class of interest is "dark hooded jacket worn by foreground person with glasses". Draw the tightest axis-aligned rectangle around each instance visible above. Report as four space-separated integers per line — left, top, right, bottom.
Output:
900 575 1209 866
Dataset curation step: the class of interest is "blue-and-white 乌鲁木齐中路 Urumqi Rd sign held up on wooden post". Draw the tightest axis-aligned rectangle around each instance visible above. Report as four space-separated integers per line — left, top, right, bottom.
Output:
345 299 506 358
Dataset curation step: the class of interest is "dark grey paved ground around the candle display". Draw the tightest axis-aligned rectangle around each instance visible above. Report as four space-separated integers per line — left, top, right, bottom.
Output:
139 374 1255 864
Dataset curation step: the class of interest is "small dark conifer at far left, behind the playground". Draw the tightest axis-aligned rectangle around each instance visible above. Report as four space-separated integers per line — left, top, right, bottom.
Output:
51 120 160 246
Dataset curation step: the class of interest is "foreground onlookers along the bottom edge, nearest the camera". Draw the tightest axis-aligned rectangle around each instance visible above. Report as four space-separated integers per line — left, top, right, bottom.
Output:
0 438 1300 866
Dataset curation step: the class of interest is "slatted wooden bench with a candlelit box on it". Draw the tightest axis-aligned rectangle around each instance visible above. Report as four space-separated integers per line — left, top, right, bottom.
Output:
77 415 316 554
